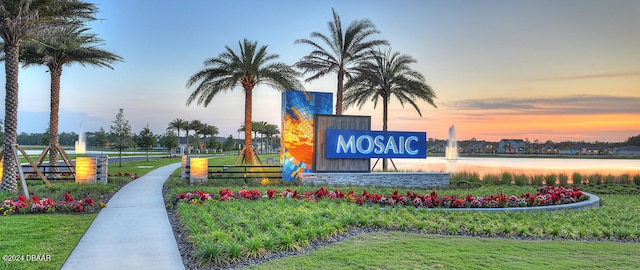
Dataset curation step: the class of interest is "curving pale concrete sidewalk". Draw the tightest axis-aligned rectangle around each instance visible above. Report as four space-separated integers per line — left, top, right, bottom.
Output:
62 163 184 270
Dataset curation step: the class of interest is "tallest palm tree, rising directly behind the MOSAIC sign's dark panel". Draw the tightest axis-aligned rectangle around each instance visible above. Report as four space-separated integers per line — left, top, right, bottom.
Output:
295 9 389 115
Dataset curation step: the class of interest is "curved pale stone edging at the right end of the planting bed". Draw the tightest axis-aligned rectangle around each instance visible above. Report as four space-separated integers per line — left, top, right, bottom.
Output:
416 192 600 212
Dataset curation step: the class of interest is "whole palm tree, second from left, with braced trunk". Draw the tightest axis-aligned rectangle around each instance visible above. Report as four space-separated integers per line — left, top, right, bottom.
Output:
20 25 122 173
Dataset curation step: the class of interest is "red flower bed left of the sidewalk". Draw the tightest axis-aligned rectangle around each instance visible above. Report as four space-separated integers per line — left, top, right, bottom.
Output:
0 193 107 216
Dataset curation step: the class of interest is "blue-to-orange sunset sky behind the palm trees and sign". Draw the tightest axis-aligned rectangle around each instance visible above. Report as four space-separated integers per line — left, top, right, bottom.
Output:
0 0 640 142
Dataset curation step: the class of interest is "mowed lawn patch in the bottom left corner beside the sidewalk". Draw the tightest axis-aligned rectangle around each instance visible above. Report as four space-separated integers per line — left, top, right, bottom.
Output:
0 213 97 269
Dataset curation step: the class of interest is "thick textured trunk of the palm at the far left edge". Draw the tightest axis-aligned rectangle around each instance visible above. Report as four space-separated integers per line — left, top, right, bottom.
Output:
0 42 20 192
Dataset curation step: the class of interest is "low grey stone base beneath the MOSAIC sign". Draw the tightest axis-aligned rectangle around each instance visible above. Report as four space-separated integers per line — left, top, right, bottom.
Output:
300 172 449 188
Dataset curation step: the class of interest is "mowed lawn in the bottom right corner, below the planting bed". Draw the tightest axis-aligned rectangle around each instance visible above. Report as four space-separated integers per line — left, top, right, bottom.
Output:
248 232 640 269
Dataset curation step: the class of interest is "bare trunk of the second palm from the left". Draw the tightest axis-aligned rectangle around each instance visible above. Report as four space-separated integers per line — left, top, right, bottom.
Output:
49 66 62 175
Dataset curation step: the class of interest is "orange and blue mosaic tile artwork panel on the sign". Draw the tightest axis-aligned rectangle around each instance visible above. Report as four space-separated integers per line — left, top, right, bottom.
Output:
280 90 333 181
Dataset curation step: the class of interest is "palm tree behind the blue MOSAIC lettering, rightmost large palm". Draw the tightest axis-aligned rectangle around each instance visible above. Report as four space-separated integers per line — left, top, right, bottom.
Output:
344 49 437 170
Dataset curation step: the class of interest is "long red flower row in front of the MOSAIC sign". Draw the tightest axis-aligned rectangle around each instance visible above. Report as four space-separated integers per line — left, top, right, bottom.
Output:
176 186 589 208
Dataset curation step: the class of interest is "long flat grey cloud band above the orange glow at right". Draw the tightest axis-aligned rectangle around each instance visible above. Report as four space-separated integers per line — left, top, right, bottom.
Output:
446 95 640 115
